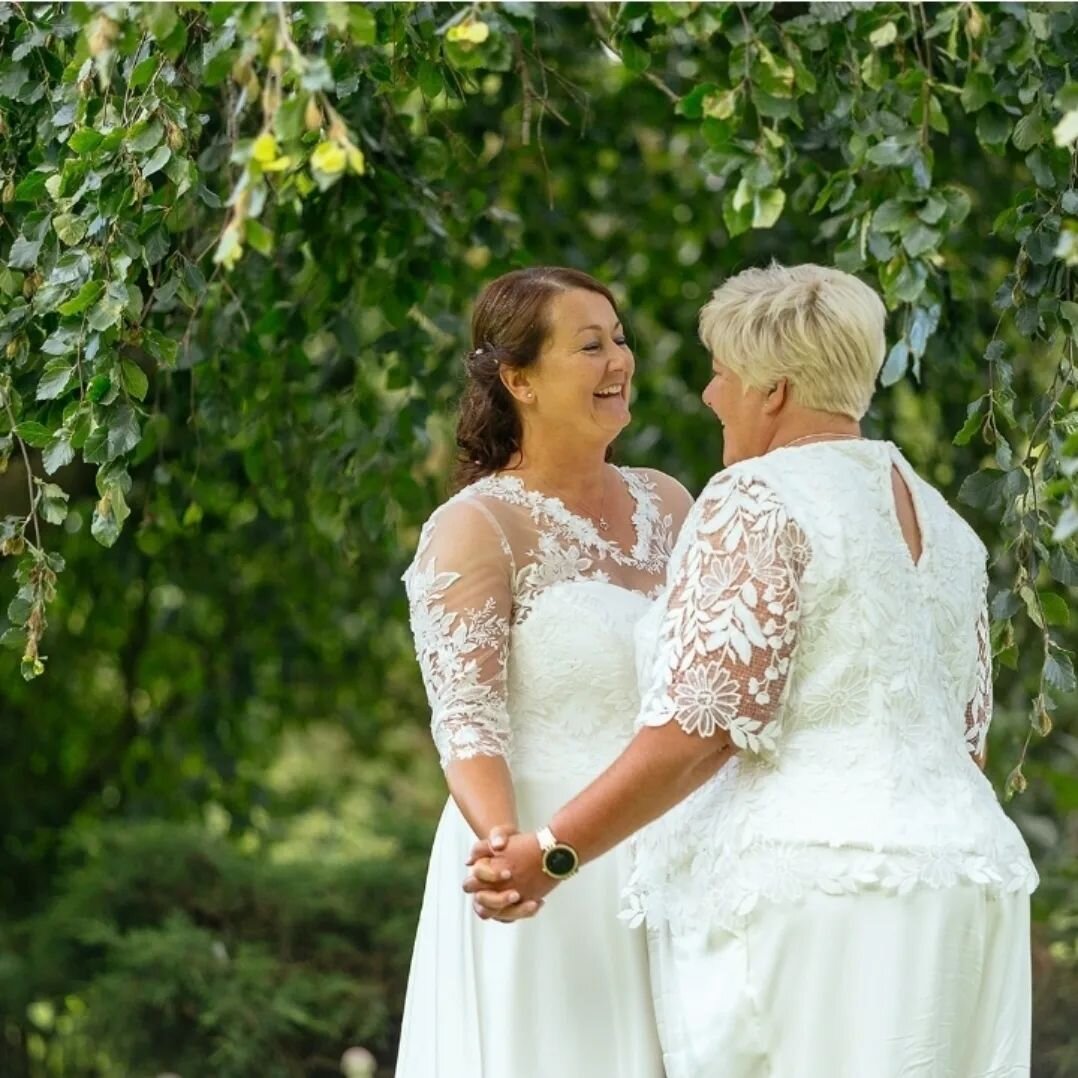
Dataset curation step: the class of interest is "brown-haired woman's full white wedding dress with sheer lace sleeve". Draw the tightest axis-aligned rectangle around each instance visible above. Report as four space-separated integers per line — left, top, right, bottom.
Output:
397 469 688 1078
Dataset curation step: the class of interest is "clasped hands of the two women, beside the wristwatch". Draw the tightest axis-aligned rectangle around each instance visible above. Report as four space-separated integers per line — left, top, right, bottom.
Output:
464 828 557 923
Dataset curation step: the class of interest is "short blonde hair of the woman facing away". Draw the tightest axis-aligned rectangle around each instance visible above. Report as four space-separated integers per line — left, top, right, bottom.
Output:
700 262 886 419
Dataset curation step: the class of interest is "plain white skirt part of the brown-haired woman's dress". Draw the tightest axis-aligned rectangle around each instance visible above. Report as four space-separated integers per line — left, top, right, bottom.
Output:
397 782 663 1078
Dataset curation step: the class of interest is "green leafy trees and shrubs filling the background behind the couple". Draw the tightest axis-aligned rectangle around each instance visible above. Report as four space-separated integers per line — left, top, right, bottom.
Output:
0 2 1078 1078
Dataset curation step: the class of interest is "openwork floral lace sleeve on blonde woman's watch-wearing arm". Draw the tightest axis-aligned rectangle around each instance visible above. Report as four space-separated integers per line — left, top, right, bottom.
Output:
639 473 811 752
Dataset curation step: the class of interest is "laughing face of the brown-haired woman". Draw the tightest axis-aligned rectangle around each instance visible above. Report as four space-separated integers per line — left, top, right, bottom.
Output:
513 289 634 443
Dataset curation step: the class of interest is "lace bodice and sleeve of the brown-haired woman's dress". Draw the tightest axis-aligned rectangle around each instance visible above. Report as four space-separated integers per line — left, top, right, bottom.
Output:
404 468 689 775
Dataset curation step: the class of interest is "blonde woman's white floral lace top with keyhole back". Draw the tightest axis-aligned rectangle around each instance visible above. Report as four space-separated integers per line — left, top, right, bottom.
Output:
623 441 1037 928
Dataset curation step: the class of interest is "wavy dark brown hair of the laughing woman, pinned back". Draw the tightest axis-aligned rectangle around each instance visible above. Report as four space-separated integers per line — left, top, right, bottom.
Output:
453 266 618 489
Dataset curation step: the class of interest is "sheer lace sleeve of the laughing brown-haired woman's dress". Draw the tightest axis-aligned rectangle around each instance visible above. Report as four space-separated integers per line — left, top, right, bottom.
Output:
404 501 512 768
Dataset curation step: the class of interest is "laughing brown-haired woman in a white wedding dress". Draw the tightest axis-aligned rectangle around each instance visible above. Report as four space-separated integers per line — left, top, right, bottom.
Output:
397 267 691 1078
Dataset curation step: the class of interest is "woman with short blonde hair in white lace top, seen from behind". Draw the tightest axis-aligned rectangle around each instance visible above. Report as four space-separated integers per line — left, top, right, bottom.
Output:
466 265 1037 1078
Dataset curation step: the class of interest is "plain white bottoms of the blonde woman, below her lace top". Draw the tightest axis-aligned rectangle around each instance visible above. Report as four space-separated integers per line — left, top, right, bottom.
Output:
648 885 1031 1078
